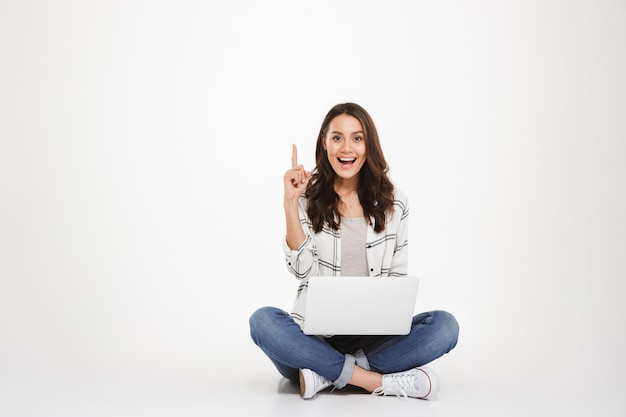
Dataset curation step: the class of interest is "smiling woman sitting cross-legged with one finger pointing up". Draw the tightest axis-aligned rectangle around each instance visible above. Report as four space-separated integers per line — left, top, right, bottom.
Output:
250 103 459 399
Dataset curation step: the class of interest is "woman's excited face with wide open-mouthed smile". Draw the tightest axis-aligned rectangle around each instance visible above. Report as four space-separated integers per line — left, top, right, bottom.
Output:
324 114 366 179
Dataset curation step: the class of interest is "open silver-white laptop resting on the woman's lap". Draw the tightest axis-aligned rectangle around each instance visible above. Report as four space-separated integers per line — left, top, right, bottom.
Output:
302 276 419 336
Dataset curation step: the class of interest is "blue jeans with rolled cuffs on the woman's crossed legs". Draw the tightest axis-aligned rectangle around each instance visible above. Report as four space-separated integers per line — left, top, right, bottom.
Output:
250 307 459 388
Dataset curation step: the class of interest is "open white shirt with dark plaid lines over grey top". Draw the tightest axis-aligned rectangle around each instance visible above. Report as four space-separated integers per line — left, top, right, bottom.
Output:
283 189 409 324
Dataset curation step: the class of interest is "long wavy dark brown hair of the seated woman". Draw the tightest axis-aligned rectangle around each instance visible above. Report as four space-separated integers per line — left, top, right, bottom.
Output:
305 103 394 233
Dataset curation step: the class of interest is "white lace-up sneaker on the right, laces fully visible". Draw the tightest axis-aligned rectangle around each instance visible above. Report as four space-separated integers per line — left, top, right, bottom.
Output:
372 366 439 400
